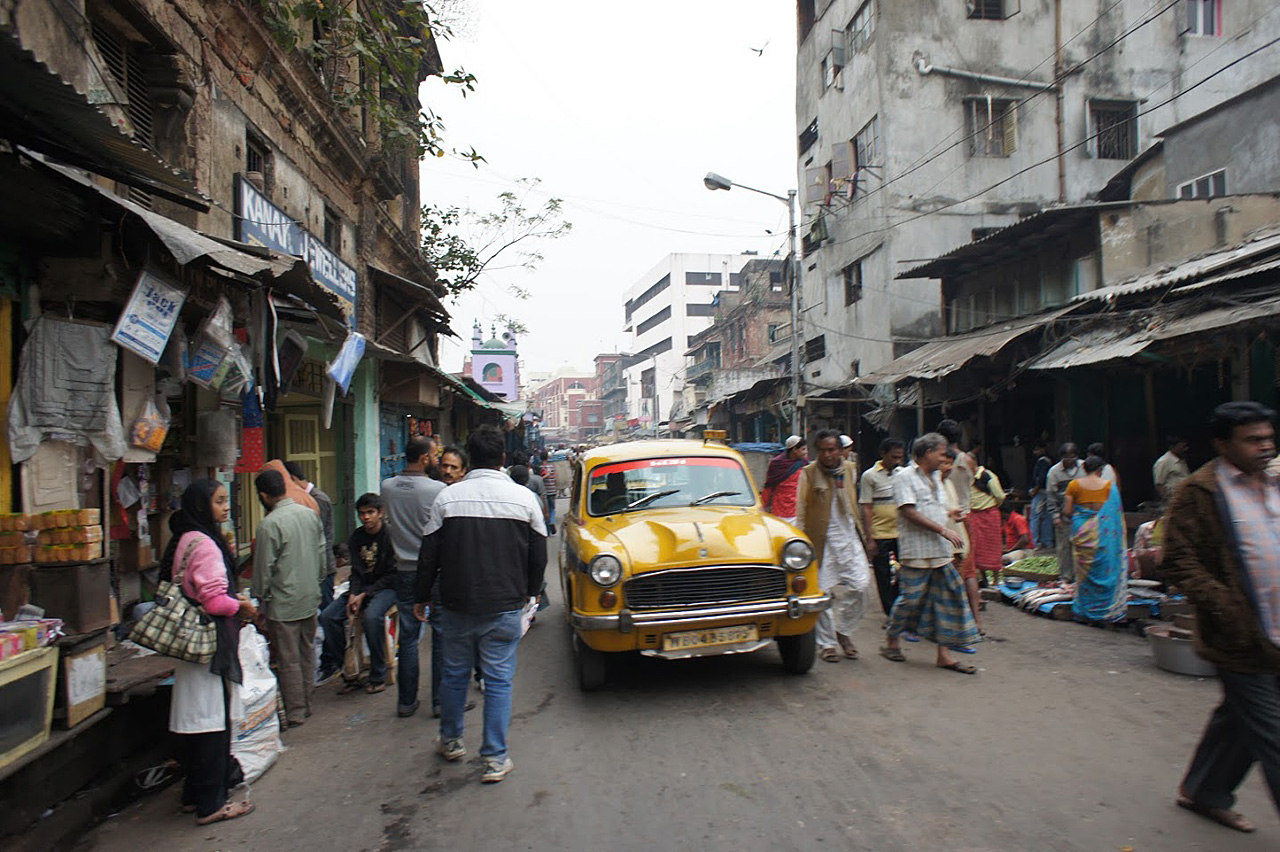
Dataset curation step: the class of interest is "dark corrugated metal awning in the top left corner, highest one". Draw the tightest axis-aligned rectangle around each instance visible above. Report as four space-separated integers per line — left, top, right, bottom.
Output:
0 35 210 211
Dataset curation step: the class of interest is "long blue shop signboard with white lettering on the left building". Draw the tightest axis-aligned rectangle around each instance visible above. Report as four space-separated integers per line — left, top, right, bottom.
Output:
236 175 356 329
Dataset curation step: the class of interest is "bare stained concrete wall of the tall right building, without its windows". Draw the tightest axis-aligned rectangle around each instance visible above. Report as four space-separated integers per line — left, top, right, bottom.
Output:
795 0 1280 386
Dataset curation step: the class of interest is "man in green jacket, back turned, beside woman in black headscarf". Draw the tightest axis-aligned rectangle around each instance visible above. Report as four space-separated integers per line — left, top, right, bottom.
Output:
253 471 325 728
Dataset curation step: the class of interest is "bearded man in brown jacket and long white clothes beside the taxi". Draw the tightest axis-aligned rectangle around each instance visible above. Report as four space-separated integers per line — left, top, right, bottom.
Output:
796 429 872 663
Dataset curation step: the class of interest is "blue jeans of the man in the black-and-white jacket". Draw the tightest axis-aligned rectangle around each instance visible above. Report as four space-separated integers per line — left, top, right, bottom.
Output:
440 608 521 760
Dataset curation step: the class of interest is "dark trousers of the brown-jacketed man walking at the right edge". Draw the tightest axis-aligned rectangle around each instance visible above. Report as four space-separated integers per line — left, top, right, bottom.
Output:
1183 669 1280 809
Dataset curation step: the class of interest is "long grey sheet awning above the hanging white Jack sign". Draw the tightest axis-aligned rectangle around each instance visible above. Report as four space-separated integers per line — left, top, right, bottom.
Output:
31 150 346 322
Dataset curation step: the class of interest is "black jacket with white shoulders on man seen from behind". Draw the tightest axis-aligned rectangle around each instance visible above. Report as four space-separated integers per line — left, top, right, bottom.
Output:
415 468 547 615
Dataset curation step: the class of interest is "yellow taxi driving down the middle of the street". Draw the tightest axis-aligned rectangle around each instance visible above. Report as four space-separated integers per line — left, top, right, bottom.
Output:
559 440 831 690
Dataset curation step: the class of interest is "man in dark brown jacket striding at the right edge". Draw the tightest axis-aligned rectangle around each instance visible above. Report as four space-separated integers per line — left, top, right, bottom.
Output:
1164 402 1280 832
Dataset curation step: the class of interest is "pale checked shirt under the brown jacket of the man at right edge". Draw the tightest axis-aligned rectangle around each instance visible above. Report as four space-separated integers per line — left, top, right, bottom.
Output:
1217 459 1280 645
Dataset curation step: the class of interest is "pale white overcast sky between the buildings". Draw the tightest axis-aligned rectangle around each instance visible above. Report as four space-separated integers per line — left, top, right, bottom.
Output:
422 0 796 375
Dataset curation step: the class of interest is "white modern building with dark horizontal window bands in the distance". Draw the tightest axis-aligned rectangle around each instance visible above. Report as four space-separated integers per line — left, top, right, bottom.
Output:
623 253 753 429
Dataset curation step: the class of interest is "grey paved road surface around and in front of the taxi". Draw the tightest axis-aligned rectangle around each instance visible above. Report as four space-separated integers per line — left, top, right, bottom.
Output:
79 521 1280 852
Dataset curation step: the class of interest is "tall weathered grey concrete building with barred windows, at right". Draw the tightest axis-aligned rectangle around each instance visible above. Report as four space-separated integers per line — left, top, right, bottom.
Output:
796 0 1280 394
